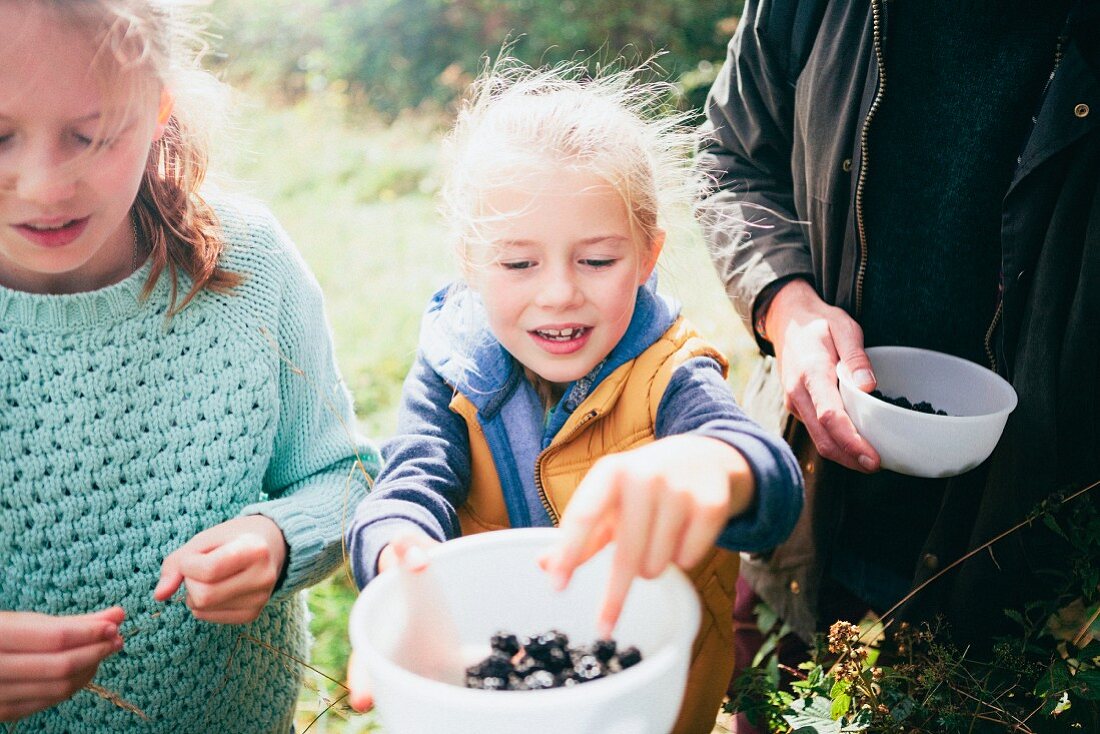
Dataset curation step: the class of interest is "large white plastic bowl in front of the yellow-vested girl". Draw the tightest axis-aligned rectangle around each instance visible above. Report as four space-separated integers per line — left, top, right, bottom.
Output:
350 528 700 734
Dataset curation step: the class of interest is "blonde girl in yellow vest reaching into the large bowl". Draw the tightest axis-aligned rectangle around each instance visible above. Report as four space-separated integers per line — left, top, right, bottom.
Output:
349 63 802 734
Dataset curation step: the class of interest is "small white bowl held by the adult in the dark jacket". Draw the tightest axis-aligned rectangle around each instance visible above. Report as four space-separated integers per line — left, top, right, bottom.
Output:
836 347 1016 478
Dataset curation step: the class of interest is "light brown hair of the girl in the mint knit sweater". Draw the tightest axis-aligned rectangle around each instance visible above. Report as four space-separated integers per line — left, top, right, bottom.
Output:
53 0 241 315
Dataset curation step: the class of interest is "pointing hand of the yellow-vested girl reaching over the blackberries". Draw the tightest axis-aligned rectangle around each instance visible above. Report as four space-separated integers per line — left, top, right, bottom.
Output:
541 436 754 637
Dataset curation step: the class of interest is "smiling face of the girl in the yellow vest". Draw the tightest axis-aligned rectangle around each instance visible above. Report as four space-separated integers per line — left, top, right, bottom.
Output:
470 166 662 390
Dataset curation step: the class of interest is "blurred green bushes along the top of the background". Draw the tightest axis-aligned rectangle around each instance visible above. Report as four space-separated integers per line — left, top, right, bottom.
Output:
211 0 744 120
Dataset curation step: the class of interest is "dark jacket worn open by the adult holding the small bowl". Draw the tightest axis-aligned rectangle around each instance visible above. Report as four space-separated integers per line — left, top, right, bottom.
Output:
699 0 1100 645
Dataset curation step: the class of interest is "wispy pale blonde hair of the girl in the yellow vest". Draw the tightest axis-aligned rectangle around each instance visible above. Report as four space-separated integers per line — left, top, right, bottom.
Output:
440 57 701 267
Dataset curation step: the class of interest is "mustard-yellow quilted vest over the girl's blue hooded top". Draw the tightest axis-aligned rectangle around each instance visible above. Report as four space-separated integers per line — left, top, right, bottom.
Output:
450 317 738 734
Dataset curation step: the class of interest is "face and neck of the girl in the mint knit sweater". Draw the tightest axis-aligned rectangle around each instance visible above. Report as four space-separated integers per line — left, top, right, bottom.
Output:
0 0 163 293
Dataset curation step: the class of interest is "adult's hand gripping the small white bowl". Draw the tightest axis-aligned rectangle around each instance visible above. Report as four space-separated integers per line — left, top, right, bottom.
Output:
765 280 879 472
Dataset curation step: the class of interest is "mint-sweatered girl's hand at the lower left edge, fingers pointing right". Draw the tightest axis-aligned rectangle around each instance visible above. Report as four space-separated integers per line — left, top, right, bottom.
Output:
0 606 125 721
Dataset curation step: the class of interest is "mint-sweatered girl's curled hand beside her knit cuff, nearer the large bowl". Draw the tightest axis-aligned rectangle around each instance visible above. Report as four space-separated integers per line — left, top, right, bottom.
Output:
153 515 287 624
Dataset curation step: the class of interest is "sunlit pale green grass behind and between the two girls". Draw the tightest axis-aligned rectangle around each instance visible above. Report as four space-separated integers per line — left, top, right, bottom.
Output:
227 90 755 734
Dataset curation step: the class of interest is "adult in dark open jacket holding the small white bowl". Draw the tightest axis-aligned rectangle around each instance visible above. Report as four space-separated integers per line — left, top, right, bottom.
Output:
699 0 1100 730
